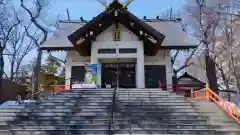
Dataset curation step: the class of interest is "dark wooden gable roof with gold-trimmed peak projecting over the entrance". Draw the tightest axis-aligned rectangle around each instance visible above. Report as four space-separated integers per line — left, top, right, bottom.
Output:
68 1 165 54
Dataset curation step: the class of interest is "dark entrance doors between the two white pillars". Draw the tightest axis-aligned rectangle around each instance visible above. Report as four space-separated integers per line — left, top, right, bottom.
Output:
101 62 136 88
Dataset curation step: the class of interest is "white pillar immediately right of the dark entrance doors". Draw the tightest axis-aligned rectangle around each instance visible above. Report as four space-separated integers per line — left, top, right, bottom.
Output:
136 45 145 88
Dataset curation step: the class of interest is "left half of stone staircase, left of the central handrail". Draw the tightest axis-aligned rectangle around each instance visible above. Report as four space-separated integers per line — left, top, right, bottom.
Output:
0 89 113 135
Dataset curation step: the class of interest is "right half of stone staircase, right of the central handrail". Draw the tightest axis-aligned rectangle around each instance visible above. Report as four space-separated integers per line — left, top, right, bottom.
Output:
111 89 240 135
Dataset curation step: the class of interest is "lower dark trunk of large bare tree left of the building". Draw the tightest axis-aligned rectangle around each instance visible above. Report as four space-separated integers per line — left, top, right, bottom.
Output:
32 49 42 98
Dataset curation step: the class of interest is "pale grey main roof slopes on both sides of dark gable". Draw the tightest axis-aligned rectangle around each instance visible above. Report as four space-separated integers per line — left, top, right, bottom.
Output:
40 20 198 49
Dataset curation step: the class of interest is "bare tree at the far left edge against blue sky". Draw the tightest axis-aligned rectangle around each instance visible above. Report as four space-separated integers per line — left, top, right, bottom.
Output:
0 1 21 88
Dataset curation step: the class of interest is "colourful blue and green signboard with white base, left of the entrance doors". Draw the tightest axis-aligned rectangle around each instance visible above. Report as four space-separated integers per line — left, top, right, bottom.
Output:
72 64 97 89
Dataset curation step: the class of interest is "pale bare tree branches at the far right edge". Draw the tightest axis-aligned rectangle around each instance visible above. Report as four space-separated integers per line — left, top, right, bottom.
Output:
215 13 240 92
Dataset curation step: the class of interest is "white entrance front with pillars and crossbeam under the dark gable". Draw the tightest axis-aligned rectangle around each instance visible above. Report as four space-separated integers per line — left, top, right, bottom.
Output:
91 24 145 88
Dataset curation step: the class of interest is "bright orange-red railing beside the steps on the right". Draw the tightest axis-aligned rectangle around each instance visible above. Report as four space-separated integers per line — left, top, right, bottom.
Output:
191 88 240 124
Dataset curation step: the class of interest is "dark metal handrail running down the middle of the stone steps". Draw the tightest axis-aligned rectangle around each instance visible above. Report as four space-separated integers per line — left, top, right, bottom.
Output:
108 88 117 135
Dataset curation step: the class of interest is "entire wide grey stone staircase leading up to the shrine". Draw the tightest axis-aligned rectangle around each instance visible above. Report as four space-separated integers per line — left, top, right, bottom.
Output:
0 89 240 135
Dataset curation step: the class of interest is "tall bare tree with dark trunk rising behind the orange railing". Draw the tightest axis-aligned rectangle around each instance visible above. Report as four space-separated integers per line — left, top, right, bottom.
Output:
185 0 230 92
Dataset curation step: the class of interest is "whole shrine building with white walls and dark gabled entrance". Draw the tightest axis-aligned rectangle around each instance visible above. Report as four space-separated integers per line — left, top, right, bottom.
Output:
41 1 197 88
